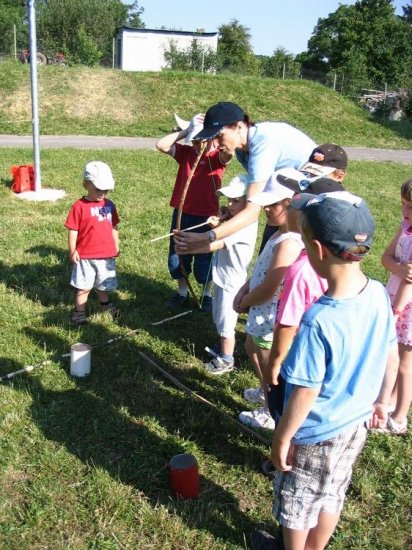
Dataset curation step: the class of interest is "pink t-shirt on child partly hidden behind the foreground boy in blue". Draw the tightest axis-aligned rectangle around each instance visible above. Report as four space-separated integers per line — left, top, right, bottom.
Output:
276 250 328 327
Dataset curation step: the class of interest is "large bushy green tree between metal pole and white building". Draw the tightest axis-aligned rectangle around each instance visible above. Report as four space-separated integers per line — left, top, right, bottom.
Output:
37 0 143 65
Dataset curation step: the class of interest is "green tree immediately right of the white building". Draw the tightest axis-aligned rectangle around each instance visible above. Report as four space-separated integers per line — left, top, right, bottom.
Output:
217 19 260 75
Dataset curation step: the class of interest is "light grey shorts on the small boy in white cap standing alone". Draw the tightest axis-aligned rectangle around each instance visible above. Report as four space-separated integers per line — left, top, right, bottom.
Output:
70 258 117 292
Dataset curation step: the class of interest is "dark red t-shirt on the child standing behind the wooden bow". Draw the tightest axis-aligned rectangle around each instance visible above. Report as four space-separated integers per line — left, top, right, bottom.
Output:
170 143 226 216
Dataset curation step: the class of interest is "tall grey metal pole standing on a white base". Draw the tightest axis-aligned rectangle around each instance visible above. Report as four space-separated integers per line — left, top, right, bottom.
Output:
27 0 41 191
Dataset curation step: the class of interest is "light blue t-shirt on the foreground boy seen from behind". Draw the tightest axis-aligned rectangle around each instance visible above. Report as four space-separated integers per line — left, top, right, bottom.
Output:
281 280 396 445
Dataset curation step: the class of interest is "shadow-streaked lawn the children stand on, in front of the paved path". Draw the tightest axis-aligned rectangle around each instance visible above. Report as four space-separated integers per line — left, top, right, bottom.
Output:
0 149 412 550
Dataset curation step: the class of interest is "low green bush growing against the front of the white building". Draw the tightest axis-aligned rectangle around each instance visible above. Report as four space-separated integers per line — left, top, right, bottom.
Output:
164 38 216 72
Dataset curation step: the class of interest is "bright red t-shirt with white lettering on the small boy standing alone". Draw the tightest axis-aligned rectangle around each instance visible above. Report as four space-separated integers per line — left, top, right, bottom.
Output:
64 197 119 259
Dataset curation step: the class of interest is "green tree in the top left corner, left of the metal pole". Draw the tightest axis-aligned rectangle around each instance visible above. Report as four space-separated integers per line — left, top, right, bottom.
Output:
0 0 28 55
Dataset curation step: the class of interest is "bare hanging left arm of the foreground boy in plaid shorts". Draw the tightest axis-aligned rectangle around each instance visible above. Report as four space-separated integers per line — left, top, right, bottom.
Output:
272 386 320 472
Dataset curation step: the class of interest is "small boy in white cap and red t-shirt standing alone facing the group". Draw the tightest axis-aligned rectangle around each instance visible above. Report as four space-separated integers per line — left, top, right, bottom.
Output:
65 161 119 325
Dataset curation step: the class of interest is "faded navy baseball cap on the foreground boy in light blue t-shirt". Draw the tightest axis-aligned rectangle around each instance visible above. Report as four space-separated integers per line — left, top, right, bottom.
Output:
291 191 375 261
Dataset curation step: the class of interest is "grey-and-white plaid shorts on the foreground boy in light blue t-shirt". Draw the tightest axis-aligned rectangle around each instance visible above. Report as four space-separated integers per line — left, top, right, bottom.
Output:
273 424 367 531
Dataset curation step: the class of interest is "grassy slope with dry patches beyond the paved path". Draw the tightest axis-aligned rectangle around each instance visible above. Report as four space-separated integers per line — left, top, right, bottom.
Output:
0 62 412 149
